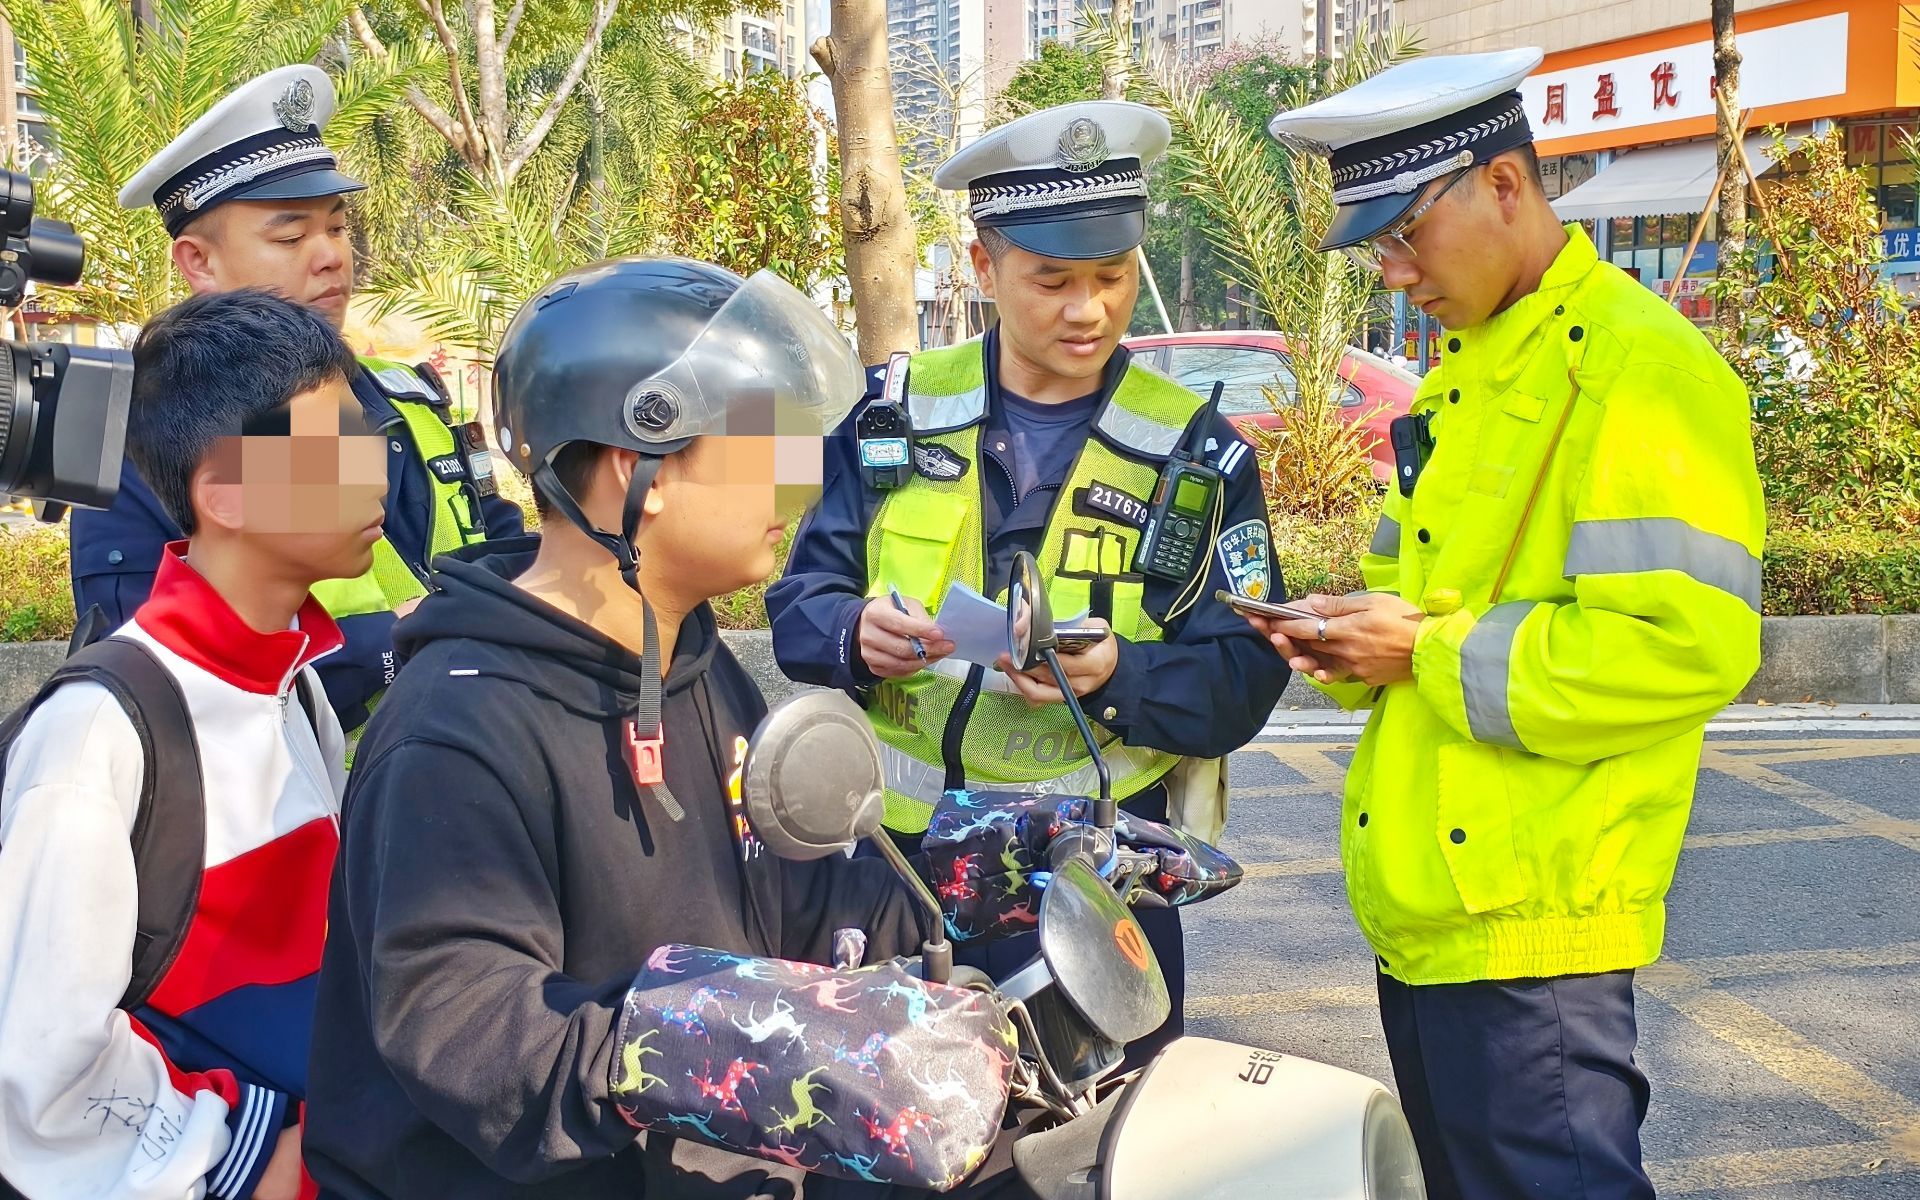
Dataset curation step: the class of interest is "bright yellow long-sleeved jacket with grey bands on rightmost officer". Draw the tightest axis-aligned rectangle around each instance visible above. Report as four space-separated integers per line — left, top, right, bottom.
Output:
1327 225 1764 983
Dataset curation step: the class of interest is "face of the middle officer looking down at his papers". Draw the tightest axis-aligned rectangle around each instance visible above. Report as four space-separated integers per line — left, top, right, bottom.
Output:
972 242 1140 392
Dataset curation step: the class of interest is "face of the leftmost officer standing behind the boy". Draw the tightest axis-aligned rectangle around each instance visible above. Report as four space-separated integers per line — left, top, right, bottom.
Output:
173 196 353 328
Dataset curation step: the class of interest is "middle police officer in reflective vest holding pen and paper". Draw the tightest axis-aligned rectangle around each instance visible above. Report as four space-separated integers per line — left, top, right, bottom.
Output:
766 102 1284 1058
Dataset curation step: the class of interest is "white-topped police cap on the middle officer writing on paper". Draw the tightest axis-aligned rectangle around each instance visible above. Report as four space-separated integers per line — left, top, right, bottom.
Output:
933 100 1173 259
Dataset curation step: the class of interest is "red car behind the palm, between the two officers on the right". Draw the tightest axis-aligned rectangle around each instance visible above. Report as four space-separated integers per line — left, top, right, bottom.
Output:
1123 328 1421 484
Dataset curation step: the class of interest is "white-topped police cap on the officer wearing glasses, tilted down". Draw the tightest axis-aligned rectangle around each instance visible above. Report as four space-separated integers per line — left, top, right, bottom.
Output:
1267 46 1542 250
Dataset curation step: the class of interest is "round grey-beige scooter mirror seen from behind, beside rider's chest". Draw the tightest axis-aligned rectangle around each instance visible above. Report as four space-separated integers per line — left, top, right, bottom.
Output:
739 691 885 862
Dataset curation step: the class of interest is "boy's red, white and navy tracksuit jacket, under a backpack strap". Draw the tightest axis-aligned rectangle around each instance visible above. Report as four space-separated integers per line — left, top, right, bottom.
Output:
0 543 346 1200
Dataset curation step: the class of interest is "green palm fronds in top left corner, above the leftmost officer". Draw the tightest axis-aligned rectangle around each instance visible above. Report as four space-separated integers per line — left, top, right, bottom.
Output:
0 0 424 324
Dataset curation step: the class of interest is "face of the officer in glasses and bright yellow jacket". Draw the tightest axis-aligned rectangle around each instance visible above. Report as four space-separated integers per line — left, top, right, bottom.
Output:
1380 156 1524 328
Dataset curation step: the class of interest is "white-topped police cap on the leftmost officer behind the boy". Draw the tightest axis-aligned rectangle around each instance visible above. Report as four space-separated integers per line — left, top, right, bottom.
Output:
119 65 367 236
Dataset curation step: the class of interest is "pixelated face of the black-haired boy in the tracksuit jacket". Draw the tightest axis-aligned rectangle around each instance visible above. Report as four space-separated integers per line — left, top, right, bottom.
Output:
194 378 386 582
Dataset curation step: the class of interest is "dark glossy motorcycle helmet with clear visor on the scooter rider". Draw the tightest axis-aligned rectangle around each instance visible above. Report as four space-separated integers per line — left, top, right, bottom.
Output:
493 257 864 586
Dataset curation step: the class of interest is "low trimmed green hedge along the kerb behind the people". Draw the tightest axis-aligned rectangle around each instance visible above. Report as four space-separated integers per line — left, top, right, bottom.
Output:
0 513 1920 641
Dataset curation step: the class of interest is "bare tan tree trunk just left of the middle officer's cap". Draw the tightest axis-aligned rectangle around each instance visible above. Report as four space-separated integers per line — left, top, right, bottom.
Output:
812 0 920 363
